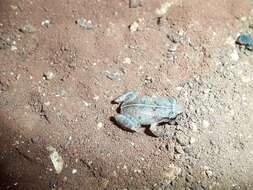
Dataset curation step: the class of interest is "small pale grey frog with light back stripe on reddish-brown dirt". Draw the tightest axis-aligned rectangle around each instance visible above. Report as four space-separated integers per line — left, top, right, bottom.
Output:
113 91 184 132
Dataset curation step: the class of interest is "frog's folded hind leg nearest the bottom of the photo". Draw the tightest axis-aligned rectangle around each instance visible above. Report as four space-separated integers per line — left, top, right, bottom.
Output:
114 114 140 132
